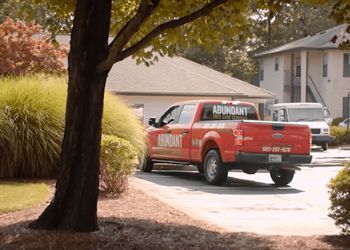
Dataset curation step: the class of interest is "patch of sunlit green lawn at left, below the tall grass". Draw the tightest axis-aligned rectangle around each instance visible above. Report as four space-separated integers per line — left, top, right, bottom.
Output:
0 181 49 214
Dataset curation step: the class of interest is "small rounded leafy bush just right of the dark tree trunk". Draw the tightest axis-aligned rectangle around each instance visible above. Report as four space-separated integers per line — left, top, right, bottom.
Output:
100 135 137 195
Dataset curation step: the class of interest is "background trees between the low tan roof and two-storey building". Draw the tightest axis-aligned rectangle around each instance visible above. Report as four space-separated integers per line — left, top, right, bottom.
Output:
180 1 336 82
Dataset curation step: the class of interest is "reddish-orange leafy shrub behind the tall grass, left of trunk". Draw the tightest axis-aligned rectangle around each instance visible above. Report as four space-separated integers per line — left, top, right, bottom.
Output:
0 19 68 76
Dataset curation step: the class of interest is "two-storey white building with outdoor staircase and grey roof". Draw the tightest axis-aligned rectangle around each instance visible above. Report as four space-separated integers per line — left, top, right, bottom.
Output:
254 24 350 118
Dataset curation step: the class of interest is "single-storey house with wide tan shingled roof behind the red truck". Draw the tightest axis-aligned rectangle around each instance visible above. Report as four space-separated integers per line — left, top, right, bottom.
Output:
56 35 273 123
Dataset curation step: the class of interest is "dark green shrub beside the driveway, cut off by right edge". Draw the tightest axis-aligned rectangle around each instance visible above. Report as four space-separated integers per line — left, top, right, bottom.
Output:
328 162 350 235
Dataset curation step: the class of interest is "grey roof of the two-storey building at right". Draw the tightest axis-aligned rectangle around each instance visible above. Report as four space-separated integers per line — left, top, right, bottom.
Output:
254 24 350 58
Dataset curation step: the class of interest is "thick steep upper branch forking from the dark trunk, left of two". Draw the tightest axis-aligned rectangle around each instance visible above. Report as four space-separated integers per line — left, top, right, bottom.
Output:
97 0 160 72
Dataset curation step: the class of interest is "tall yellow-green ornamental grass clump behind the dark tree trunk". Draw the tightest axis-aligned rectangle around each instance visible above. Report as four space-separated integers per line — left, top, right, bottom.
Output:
0 76 144 178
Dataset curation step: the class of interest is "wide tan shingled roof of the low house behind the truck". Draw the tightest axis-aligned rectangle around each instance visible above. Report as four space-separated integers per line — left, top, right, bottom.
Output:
56 36 273 99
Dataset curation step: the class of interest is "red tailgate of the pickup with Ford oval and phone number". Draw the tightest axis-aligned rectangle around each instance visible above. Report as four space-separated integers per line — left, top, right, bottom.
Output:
242 120 311 154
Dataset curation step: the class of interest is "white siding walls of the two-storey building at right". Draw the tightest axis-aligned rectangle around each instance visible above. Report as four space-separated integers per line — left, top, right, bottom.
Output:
260 50 350 118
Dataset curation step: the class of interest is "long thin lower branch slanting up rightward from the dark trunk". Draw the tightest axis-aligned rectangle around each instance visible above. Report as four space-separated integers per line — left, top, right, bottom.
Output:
115 0 228 62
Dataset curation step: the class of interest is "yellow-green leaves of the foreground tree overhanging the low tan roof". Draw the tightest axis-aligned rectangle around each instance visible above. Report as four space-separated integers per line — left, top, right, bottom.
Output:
17 0 256 65
